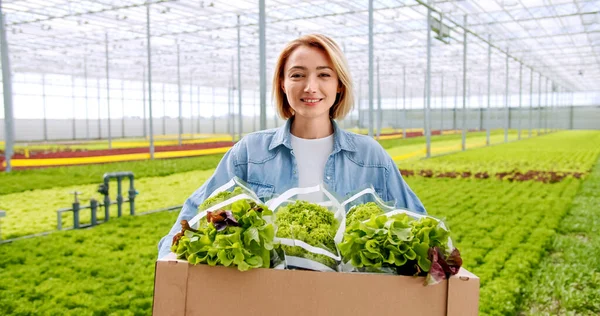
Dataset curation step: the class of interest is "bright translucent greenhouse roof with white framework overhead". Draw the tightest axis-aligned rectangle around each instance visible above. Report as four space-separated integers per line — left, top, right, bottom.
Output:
2 0 600 94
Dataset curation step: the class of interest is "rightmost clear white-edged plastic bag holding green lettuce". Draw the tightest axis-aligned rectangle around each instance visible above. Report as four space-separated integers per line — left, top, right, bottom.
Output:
338 187 454 275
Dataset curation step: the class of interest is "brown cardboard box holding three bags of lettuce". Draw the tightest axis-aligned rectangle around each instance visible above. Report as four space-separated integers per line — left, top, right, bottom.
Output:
153 256 479 316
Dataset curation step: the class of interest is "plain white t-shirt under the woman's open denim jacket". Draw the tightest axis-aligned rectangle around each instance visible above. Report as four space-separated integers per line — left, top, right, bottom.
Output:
291 134 333 203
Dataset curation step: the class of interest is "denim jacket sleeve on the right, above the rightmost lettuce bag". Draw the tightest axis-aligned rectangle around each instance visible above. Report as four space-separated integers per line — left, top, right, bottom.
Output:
386 157 427 214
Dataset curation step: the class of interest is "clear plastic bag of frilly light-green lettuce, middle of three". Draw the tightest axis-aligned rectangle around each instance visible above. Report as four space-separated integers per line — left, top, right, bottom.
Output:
267 184 346 271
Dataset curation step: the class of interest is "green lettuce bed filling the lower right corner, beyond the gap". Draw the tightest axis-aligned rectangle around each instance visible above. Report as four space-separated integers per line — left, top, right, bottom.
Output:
523 157 600 316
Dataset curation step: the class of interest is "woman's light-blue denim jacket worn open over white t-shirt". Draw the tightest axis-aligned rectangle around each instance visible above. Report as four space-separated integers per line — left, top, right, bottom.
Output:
158 120 426 258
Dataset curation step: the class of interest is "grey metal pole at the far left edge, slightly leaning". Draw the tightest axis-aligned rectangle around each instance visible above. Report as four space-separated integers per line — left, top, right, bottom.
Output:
0 11 15 172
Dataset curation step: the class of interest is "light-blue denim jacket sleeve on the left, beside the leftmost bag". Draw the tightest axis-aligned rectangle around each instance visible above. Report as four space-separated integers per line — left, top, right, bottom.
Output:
158 142 246 259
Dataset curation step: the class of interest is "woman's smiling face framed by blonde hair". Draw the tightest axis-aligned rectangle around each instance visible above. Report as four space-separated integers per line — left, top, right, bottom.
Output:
281 45 340 120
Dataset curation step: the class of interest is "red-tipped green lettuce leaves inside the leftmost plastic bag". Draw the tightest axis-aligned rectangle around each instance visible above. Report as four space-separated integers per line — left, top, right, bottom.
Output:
171 200 275 271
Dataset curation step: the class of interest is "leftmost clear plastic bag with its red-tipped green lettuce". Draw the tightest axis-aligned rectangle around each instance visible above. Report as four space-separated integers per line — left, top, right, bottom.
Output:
171 178 281 271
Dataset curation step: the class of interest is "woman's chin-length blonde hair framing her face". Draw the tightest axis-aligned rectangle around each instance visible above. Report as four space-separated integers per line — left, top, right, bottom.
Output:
273 34 354 120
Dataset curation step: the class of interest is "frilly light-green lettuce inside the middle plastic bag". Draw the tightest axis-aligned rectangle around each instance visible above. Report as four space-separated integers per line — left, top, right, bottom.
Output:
275 201 339 268
